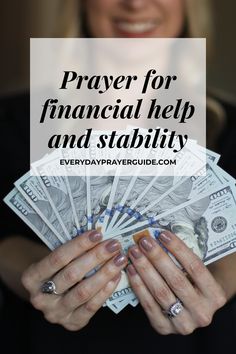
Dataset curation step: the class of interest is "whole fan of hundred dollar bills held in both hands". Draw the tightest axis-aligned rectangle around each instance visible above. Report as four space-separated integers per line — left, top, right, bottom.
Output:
4 136 236 313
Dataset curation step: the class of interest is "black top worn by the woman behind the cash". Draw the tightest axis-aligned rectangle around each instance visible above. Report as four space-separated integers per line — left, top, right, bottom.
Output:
0 95 236 354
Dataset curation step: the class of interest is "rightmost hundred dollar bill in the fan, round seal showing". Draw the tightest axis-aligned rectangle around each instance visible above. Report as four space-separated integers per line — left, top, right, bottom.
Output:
110 184 236 264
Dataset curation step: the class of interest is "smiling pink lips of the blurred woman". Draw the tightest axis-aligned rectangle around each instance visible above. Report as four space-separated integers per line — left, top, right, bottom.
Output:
114 19 161 38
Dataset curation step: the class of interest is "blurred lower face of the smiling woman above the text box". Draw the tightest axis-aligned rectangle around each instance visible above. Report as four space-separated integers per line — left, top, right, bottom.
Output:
83 0 185 38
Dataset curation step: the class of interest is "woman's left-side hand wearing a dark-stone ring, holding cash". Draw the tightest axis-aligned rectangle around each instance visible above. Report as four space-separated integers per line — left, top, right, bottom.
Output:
22 231 127 331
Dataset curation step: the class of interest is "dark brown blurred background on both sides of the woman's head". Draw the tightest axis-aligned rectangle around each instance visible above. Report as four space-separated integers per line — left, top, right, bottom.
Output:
0 0 236 100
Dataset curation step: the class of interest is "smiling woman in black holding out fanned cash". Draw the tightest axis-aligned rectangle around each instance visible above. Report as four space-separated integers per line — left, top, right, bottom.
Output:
0 0 236 354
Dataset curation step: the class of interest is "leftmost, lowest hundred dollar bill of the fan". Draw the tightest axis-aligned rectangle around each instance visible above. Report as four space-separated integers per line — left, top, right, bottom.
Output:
4 188 64 250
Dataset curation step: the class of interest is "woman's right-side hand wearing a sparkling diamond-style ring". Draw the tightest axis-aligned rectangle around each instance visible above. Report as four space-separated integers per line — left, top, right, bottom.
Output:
128 231 226 335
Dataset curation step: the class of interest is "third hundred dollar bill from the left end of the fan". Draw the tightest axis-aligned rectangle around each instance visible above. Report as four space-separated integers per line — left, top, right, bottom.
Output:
32 152 78 240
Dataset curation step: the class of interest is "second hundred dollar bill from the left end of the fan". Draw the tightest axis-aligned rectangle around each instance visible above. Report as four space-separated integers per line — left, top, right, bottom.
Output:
15 171 67 242
